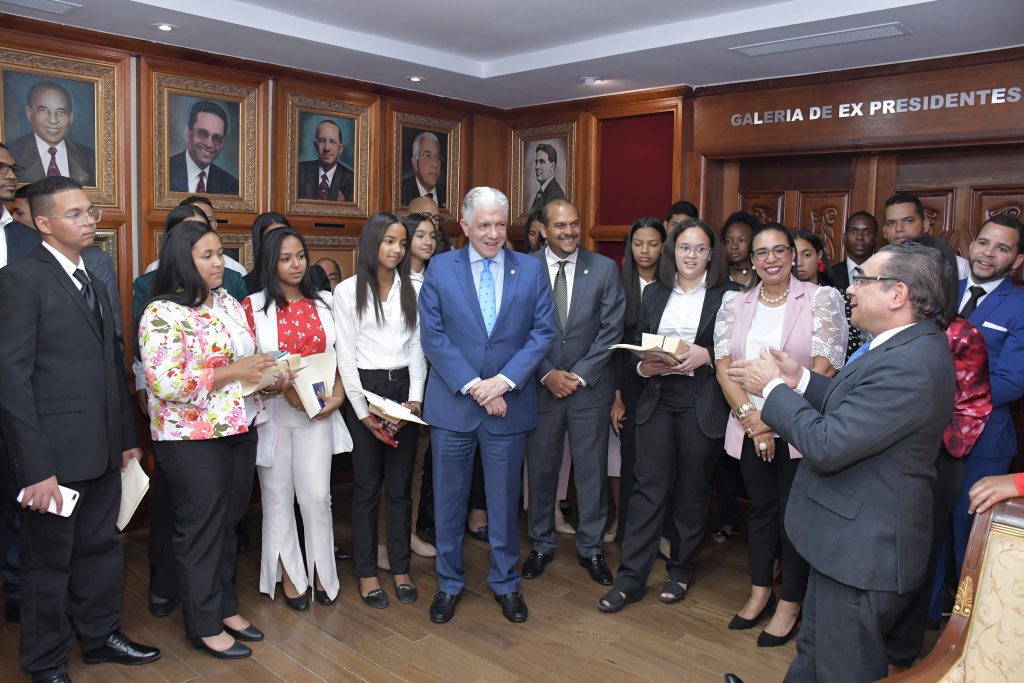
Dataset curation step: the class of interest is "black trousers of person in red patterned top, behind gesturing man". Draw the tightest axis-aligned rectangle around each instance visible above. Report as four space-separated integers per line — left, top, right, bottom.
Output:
886 449 964 667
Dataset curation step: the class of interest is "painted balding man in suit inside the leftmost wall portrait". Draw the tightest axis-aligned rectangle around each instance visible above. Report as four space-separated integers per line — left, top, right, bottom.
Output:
9 81 96 185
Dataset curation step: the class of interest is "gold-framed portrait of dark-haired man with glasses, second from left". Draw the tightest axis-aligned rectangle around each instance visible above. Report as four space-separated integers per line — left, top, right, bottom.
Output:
151 71 261 212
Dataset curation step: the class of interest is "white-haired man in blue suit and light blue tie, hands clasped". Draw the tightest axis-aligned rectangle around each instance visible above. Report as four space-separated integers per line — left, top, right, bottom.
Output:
420 187 555 624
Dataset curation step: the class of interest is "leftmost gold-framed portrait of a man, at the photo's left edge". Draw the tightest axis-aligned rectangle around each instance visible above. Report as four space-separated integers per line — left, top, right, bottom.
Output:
0 47 121 207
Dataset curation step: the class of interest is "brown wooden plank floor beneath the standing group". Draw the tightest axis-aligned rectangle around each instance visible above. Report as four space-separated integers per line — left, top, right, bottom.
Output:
0 488 796 683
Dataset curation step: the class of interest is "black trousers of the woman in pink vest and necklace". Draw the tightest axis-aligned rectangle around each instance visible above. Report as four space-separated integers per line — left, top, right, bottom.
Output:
739 437 808 602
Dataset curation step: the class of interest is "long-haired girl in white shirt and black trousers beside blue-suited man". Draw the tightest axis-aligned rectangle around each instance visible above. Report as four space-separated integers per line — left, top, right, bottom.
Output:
334 212 426 609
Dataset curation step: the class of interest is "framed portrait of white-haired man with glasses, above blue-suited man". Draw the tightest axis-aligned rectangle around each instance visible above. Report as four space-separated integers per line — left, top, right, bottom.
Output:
391 112 463 218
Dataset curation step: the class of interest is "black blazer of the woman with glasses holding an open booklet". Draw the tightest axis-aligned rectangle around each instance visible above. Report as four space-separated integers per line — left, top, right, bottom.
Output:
633 280 739 438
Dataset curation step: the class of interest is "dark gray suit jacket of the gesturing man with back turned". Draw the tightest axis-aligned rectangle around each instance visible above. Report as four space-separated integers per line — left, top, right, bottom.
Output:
761 321 956 594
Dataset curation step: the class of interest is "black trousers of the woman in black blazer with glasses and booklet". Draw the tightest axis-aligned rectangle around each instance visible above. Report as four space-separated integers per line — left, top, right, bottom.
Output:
615 377 722 594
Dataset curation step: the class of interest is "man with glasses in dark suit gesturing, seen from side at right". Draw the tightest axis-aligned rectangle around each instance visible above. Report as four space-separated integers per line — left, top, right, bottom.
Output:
729 243 955 683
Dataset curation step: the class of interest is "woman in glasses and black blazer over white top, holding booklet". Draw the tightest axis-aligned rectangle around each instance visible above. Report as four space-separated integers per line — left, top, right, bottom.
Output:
597 218 738 612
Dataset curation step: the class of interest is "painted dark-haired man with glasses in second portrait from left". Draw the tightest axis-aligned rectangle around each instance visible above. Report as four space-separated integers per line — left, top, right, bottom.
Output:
167 99 239 195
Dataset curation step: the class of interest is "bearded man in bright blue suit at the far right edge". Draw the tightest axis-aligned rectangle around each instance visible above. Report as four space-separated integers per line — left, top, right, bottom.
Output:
929 215 1024 622
